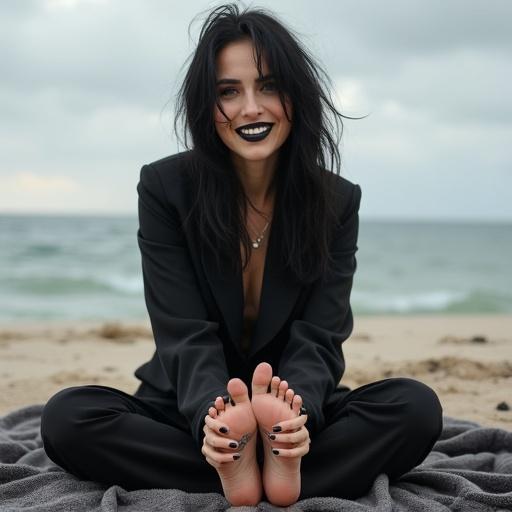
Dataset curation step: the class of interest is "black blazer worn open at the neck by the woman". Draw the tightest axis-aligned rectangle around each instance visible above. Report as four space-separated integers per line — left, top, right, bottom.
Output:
135 151 361 445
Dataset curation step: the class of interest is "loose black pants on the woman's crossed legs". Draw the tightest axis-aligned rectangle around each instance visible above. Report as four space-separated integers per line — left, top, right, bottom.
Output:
41 378 442 499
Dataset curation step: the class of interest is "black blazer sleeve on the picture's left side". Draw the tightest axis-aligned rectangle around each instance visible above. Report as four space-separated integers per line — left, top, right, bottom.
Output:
137 164 229 445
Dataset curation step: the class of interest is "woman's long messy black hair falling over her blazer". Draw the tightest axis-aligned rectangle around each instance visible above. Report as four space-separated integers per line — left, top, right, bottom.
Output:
174 3 360 284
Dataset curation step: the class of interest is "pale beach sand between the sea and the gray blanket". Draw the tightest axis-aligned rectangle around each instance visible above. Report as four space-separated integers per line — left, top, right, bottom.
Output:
0 315 512 431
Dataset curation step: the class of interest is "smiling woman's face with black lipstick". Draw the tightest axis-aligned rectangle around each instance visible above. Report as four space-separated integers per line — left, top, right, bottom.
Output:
215 40 292 165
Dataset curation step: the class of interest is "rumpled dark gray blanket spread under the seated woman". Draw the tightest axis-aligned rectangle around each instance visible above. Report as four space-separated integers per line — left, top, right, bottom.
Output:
0 405 512 512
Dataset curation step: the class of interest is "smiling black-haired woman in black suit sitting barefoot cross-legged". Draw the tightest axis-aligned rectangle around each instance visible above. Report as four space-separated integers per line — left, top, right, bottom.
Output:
41 5 442 506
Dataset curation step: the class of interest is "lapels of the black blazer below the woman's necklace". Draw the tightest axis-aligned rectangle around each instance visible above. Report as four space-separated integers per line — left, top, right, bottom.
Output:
202 210 301 356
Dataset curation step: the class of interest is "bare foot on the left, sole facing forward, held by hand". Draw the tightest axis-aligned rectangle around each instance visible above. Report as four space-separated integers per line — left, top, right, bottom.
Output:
209 379 262 506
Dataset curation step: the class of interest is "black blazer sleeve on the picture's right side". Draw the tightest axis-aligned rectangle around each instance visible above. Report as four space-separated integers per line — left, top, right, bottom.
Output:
278 181 361 434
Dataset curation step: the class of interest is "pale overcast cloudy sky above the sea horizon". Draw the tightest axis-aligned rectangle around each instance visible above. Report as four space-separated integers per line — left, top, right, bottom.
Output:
0 0 512 221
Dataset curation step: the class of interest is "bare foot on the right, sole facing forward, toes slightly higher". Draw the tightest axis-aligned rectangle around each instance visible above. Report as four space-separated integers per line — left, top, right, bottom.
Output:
251 363 302 506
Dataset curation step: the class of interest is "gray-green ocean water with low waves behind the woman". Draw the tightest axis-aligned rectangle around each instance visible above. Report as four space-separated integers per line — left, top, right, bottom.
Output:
0 214 512 323
